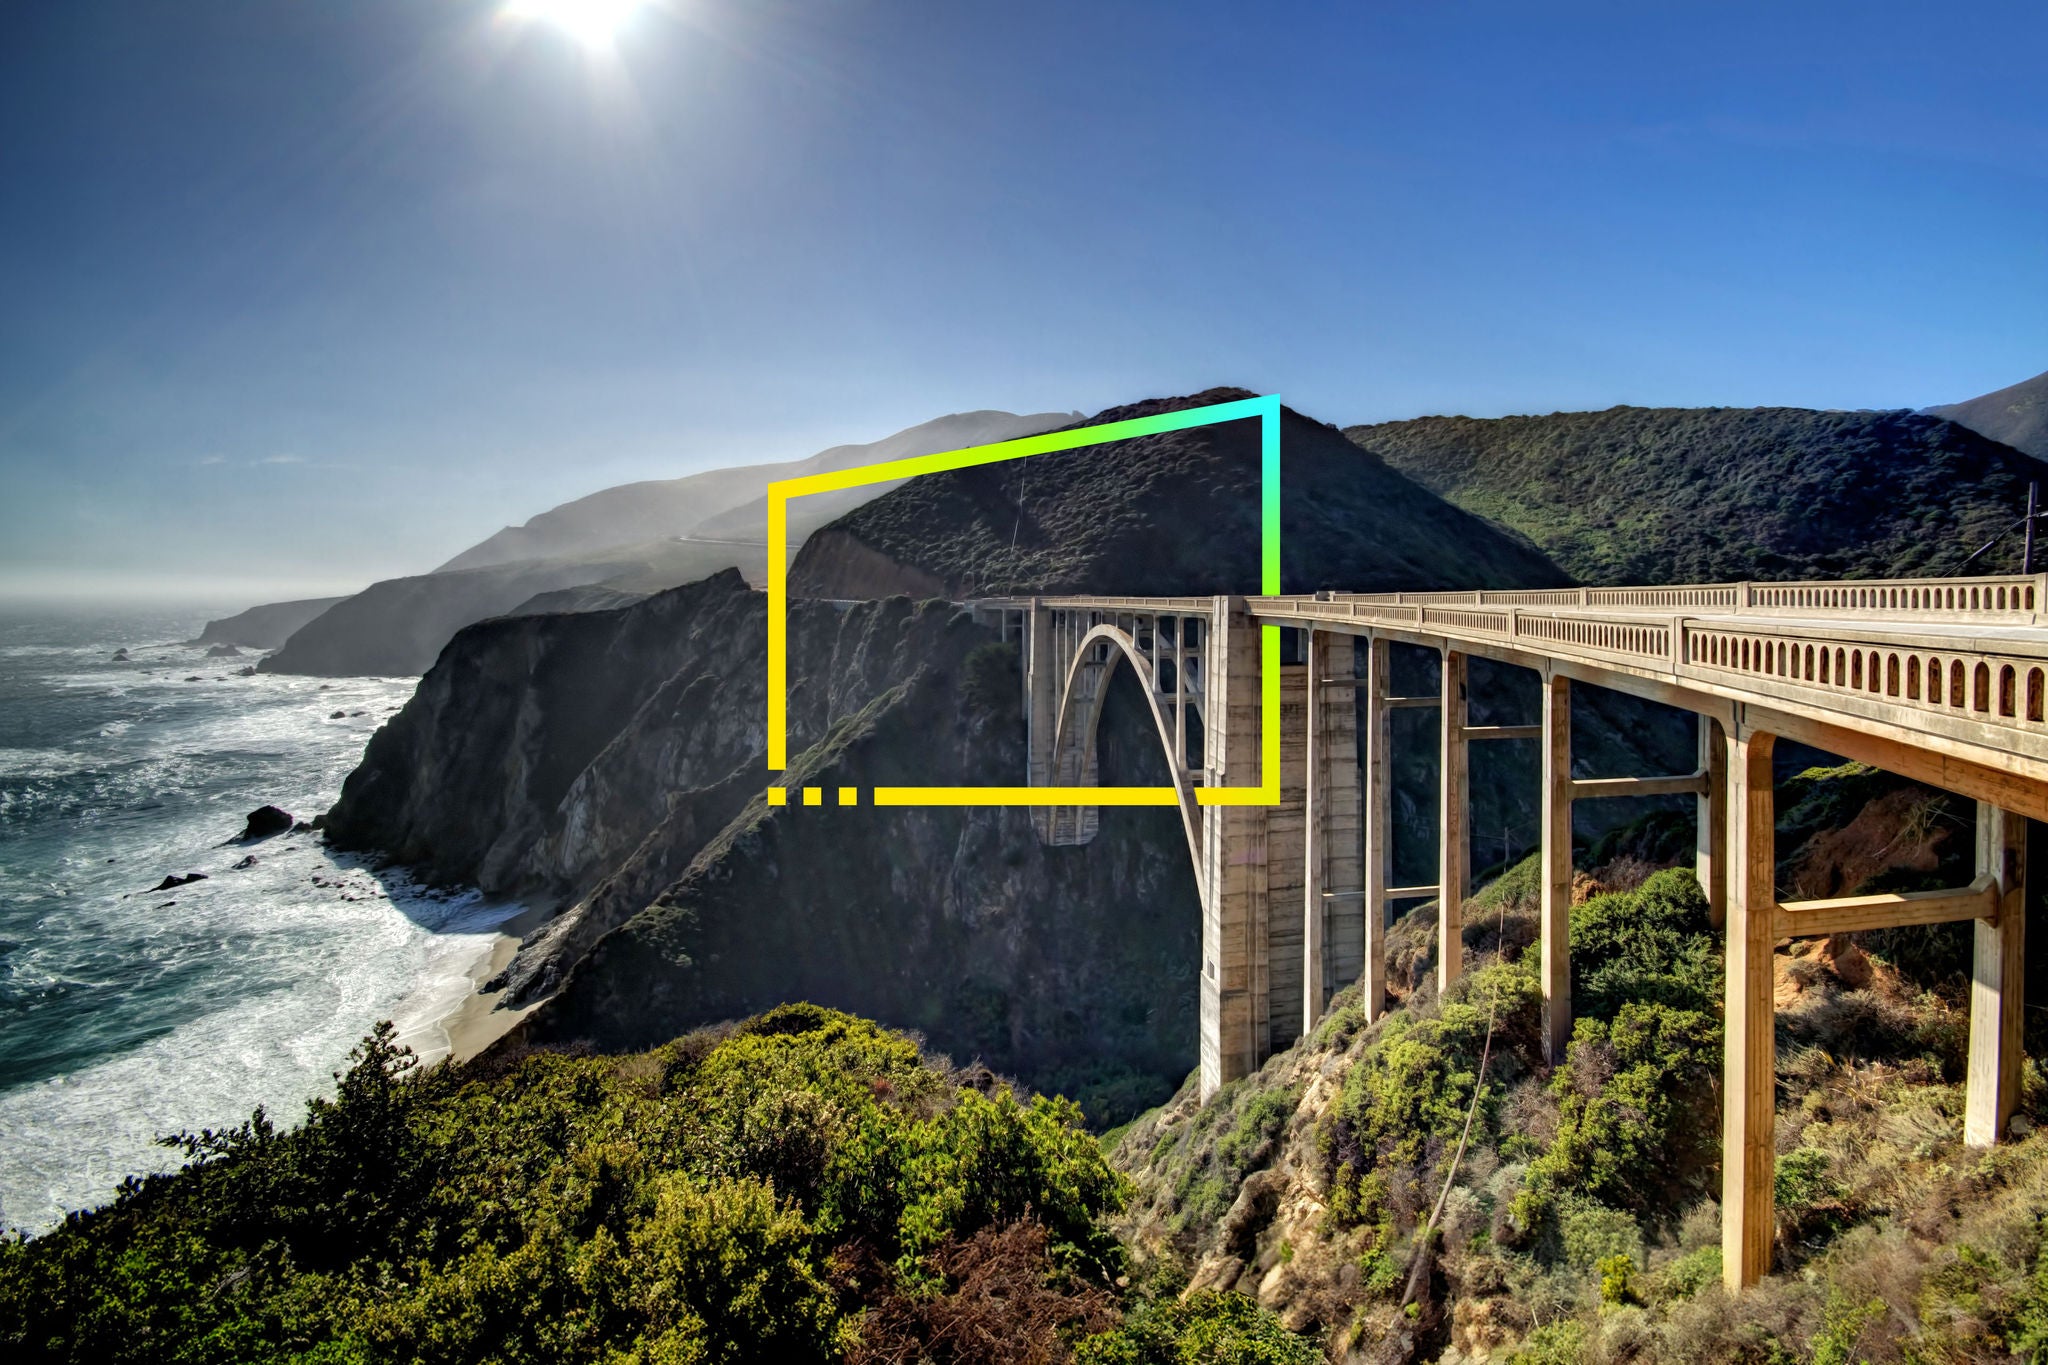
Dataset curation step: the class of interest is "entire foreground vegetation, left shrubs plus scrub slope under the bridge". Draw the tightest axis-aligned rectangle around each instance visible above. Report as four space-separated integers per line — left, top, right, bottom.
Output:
0 765 2048 1365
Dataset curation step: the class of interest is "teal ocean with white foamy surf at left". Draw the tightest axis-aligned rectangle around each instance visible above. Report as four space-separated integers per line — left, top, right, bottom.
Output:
0 608 518 1232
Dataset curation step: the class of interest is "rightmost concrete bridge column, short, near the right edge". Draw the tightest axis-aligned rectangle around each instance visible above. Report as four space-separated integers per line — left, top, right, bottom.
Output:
1962 800 2028 1146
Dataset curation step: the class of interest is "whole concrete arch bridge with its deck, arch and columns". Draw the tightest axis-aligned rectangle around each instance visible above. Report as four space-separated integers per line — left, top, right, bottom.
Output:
975 575 2048 1285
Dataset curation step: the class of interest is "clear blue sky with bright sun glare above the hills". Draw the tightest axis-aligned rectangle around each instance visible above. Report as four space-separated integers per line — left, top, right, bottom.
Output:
0 0 2048 600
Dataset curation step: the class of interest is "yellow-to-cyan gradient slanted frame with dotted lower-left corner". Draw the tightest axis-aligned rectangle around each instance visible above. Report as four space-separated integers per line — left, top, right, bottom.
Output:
768 393 1280 806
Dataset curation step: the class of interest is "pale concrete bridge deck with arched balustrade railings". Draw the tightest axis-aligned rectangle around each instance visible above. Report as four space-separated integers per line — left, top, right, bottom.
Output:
978 575 2048 794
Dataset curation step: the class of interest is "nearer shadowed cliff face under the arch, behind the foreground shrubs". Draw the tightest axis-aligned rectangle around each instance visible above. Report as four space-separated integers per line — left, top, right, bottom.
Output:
520 630 1200 1126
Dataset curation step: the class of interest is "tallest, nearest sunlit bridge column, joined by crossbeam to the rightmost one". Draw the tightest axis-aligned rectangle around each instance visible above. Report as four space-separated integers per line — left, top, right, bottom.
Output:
1720 731 1778 1289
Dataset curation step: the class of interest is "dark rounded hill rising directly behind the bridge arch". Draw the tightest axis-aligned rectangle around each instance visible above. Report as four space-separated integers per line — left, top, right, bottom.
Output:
788 387 1567 598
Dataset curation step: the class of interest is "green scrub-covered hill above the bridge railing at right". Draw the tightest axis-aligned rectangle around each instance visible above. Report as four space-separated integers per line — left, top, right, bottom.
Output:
1346 407 2048 587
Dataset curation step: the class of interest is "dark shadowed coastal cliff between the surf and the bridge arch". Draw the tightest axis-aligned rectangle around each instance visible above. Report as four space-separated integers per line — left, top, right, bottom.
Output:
328 573 1198 1113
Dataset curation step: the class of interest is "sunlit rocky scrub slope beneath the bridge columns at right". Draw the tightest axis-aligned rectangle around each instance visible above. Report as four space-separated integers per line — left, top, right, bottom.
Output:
1112 765 2048 1365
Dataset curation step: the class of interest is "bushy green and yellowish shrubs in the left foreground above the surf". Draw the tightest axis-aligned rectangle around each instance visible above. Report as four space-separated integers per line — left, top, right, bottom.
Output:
0 1005 1313 1365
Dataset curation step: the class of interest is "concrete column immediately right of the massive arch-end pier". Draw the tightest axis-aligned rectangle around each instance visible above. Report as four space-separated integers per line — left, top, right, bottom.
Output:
1300 630 1366 1033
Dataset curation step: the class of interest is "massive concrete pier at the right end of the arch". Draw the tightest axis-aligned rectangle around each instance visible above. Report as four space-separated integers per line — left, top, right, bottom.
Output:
1200 598 1270 1101
